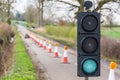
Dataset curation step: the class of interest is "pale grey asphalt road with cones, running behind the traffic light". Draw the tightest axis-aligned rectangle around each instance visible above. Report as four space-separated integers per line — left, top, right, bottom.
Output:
18 25 120 80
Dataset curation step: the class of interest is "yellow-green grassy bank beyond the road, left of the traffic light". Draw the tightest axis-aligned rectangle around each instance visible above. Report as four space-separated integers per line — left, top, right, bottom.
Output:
35 25 77 49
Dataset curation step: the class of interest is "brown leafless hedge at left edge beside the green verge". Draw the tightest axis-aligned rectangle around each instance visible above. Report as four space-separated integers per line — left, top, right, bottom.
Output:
0 23 14 77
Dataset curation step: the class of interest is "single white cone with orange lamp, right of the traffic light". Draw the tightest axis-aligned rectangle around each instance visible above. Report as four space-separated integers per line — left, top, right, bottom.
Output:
108 62 117 80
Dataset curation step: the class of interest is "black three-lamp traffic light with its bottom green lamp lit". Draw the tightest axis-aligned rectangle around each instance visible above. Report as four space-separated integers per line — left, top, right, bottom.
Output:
77 12 100 77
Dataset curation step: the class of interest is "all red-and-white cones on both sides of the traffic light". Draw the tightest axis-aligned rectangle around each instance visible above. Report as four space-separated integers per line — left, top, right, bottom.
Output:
27 31 117 80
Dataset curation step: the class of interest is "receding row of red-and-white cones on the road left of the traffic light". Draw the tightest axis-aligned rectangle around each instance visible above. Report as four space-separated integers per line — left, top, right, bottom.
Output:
30 32 68 63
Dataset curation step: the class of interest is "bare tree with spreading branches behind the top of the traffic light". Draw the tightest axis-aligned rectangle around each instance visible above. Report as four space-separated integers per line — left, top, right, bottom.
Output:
54 0 120 24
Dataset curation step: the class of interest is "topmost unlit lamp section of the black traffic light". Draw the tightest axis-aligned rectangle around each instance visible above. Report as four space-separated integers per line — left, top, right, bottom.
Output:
78 12 100 33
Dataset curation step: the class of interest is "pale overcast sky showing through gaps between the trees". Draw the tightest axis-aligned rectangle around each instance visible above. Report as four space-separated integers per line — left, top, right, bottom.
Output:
13 0 120 24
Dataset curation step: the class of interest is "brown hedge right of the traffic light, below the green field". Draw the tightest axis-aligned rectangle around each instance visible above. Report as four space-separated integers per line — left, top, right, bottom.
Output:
101 37 120 59
